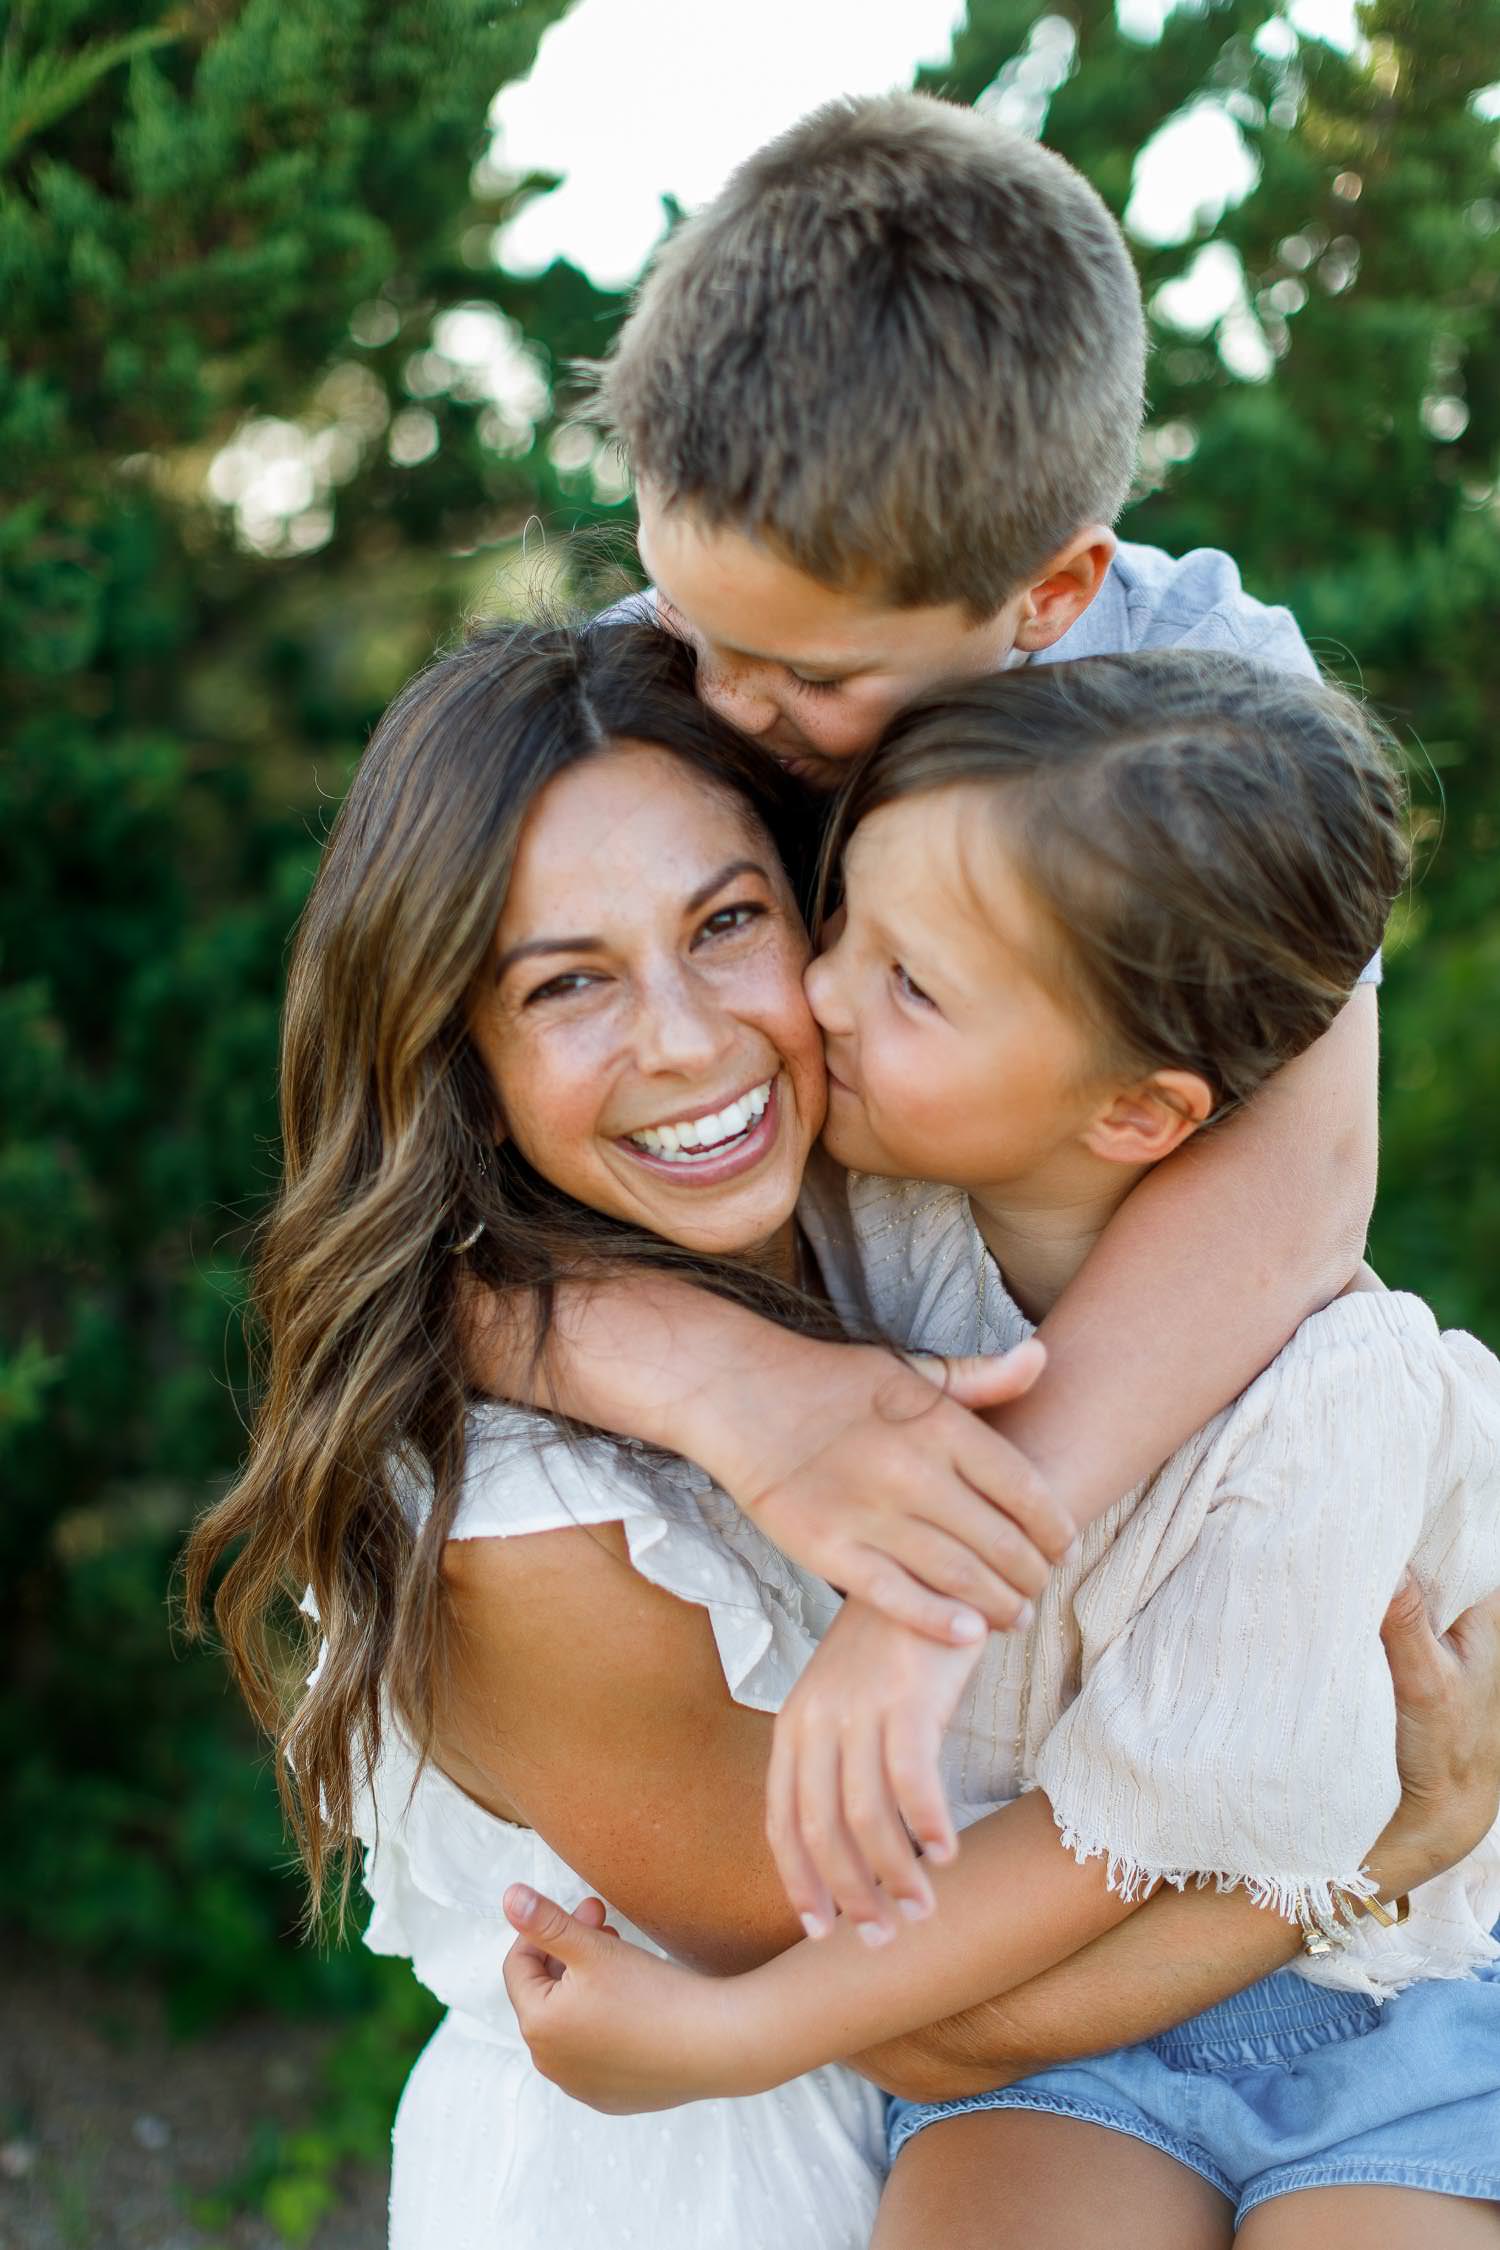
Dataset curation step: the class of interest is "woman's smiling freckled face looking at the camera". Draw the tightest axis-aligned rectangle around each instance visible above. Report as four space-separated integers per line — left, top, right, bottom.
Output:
470 743 825 1256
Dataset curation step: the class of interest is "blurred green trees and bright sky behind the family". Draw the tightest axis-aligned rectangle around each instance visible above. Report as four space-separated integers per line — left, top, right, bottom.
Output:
0 0 1500 2250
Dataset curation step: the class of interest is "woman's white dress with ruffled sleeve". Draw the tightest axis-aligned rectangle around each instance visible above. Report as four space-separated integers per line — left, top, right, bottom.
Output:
360 1406 886 2250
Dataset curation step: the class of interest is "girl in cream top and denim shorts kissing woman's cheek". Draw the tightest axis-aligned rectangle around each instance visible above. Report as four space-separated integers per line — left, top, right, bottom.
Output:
508 653 1500 2246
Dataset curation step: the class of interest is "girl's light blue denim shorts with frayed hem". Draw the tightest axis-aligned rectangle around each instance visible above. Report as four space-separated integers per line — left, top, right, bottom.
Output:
888 1931 1500 2225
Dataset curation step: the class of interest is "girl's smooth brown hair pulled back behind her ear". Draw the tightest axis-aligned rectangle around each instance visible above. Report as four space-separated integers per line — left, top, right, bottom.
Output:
819 648 1408 1114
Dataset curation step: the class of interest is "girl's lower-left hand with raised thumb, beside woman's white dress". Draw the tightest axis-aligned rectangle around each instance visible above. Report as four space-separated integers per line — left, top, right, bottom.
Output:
504 1883 751 2117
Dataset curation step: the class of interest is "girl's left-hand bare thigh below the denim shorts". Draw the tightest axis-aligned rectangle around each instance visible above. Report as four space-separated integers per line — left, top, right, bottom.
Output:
870 2111 1232 2250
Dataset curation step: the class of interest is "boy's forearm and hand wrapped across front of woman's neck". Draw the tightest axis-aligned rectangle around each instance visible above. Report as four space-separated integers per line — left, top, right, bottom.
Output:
463 1271 1073 1645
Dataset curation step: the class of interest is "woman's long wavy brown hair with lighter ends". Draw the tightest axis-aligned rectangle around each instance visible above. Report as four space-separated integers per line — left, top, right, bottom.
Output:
184 621 832 1910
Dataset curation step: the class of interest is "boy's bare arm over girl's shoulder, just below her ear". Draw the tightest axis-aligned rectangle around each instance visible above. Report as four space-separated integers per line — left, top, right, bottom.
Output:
1016 986 1379 1526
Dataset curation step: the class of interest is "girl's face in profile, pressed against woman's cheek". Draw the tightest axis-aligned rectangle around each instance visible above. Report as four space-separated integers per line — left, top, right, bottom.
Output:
807 785 1115 1195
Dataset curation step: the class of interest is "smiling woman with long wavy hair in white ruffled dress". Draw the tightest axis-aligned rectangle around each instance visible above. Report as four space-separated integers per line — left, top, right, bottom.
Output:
189 628 1482 2250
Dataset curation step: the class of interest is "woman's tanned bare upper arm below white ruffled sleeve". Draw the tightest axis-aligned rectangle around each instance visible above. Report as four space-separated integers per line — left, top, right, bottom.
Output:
436 1523 801 1973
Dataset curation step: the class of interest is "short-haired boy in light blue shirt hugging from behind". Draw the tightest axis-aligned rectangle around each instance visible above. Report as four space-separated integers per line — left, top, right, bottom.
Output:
490 95 1376 1638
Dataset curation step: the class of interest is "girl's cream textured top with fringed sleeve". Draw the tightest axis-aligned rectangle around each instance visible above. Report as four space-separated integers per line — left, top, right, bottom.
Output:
803 1168 1500 1998
